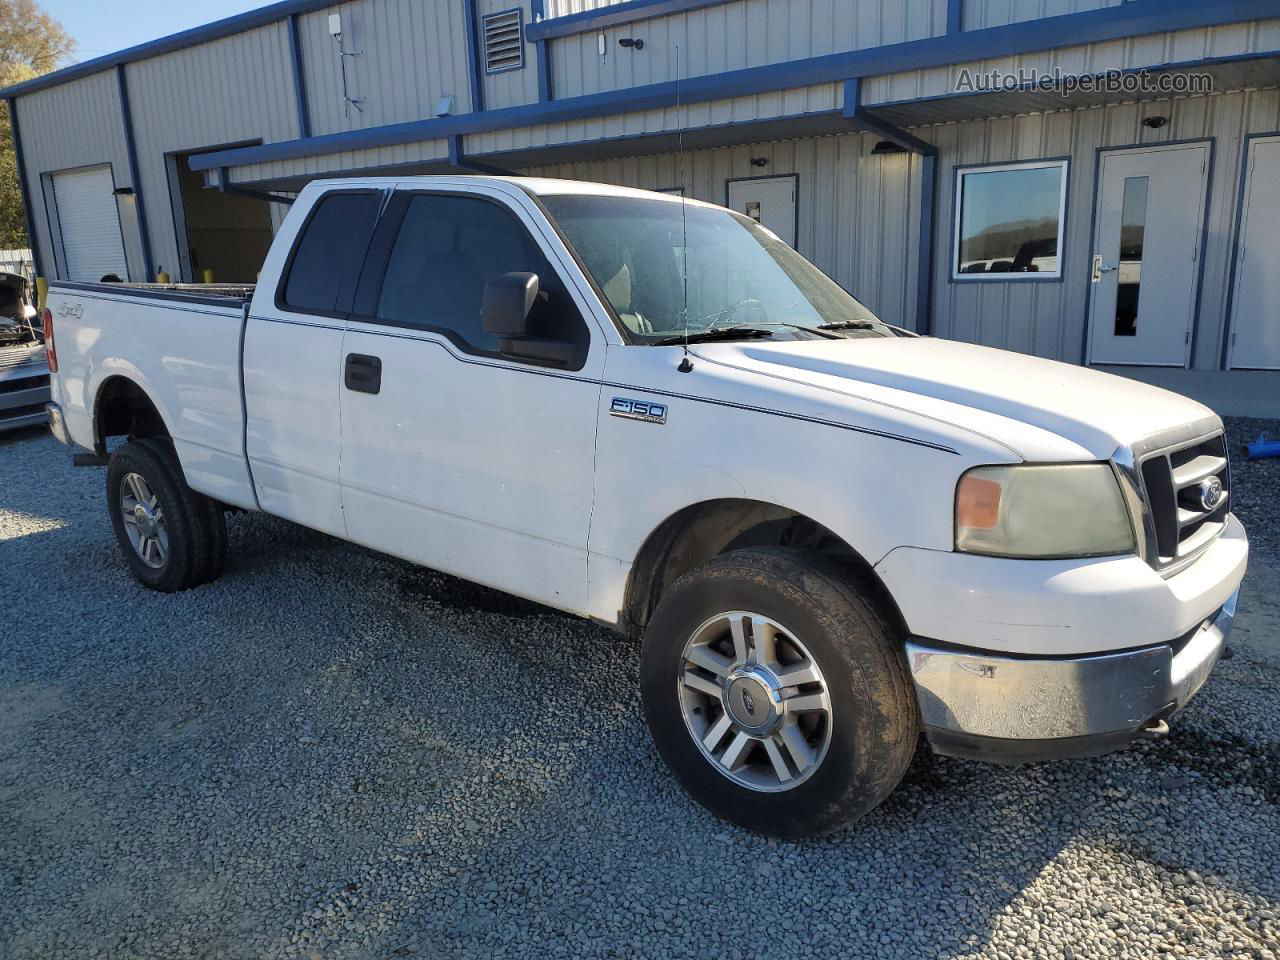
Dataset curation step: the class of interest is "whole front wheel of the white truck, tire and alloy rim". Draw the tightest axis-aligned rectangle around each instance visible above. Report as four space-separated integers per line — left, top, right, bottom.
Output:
640 549 918 837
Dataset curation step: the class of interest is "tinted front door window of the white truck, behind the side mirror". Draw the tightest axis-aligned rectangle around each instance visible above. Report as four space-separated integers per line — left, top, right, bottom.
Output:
378 193 588 356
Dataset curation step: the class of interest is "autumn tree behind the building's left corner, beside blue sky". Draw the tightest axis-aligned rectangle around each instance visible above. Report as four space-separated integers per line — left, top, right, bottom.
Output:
0 0 76 248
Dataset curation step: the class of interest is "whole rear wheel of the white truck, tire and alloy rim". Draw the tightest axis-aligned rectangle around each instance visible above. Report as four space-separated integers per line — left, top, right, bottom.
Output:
106 439 227 593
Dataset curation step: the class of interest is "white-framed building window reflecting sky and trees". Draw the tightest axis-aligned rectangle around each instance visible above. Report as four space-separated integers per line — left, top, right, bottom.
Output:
951 160 1066 280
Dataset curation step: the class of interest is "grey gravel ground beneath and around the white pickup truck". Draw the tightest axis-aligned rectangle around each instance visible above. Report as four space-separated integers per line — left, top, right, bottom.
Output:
0 424 1280 960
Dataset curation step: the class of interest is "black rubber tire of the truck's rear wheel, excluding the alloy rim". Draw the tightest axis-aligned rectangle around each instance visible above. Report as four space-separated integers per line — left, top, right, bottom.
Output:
106 438 227 593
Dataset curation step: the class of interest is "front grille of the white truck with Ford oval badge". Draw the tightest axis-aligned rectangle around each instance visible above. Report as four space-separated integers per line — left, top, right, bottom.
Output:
1138 431 1231 570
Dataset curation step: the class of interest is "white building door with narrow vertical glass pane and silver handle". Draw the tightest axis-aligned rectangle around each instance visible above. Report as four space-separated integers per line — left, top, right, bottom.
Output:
1089 143 1208 366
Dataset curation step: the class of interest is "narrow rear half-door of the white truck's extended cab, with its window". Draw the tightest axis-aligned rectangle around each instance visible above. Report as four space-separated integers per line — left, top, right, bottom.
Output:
244 188 385 536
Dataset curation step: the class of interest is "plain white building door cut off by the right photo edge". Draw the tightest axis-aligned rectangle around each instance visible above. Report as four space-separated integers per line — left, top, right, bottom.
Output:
1229 137 1280 370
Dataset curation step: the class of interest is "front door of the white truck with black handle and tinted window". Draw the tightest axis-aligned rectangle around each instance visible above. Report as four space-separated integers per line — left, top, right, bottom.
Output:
342 184 604 611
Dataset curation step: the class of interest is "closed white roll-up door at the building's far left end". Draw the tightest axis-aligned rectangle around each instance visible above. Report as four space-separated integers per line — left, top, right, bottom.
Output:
52 166 128 280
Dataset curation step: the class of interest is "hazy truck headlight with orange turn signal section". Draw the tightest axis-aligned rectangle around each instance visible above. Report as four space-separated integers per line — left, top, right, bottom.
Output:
956 463 1135 559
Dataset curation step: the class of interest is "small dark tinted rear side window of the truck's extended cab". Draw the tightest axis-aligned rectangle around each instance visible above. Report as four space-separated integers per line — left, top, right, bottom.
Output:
280 192 381 314
